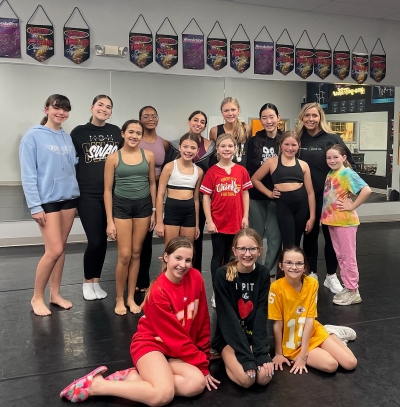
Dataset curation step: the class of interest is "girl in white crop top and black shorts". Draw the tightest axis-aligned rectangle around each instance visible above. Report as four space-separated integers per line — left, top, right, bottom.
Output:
156 133 203 246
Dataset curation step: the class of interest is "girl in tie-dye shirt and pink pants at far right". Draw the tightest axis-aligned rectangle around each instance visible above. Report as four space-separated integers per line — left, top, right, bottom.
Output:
321 144 371 305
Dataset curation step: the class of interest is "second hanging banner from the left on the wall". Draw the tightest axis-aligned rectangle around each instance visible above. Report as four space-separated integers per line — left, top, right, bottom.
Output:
26 24 54 62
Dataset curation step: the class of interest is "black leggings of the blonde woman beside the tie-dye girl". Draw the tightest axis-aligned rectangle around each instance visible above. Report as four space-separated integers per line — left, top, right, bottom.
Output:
303 192 338 274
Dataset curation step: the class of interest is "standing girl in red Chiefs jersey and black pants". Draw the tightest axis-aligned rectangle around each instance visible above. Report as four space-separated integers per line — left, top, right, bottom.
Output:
200 133 252 290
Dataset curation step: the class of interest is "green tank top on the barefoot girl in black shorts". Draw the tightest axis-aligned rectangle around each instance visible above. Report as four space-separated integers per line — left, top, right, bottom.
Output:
114 149 150 199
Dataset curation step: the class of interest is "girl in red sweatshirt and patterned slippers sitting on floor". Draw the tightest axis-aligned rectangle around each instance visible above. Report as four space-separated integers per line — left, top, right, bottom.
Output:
60 236 219 406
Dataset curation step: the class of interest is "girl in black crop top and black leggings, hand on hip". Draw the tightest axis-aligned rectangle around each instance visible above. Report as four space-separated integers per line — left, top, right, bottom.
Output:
251 131 315 247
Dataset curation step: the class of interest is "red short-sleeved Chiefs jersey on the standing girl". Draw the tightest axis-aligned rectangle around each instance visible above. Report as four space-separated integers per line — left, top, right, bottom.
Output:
200 164 253 235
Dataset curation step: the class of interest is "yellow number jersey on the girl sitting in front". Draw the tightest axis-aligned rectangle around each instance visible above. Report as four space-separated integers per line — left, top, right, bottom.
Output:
268 277 329 359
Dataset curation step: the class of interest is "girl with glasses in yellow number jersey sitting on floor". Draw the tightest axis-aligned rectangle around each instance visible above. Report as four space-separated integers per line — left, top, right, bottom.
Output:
268 246 357 374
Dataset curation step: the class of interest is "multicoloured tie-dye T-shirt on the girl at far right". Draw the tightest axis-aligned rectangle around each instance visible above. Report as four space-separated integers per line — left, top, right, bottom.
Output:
321 167 367 227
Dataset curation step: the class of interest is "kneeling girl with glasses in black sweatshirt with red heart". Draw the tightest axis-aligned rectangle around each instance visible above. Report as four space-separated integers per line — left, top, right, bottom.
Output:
212 229 274 388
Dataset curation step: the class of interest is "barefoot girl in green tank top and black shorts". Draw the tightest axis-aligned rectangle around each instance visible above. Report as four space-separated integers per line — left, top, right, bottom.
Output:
104 120 156 315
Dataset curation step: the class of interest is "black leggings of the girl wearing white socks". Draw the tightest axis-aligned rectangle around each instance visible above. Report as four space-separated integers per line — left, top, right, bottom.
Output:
78 196 107 280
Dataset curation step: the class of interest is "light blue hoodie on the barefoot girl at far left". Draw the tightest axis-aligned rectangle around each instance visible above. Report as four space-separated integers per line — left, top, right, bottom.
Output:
19 126 79 215
